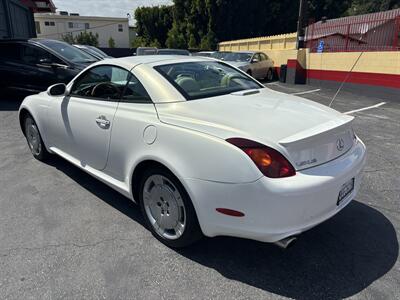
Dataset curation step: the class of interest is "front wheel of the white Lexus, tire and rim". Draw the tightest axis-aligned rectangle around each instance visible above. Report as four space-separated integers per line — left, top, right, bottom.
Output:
23 115 50 161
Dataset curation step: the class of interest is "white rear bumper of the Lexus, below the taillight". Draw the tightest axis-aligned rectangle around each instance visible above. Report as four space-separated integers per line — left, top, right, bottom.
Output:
183 141 366 242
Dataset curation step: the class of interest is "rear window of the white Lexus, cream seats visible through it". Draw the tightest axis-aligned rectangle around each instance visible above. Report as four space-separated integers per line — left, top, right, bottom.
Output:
155 61 263 100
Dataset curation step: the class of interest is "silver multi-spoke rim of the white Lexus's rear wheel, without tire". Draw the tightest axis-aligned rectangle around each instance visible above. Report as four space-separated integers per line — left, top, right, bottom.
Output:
142 175 186 240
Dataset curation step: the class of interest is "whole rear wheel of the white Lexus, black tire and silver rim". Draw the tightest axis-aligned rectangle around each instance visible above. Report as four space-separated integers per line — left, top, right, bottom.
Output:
139 167 203 248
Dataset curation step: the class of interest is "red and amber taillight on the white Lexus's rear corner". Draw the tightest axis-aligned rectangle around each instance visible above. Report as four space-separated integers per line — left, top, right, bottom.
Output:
226 138 296 178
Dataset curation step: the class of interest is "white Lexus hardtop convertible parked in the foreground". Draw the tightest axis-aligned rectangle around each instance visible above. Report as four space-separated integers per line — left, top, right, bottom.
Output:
19 56 365 247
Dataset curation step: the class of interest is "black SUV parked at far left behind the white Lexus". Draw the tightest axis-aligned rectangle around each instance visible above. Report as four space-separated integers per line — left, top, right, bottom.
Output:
0 39 97 95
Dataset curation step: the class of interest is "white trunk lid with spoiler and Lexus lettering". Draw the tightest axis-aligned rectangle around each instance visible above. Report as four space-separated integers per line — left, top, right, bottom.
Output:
156 89 353 170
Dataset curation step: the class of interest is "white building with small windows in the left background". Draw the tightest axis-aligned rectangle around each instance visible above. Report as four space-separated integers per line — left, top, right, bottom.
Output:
35 12 130 48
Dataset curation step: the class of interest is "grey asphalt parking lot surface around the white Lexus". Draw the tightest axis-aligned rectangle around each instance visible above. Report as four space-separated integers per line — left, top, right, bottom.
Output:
0 82 400 299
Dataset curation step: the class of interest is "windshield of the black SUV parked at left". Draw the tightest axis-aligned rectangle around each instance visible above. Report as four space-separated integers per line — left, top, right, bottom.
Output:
40 40 97 63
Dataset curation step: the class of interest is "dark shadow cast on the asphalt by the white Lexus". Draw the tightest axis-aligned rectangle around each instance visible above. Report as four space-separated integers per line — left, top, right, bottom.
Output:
43 157 399 299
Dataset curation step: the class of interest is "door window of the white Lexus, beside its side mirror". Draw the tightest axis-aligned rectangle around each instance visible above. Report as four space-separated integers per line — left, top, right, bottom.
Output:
71 66 130 100
